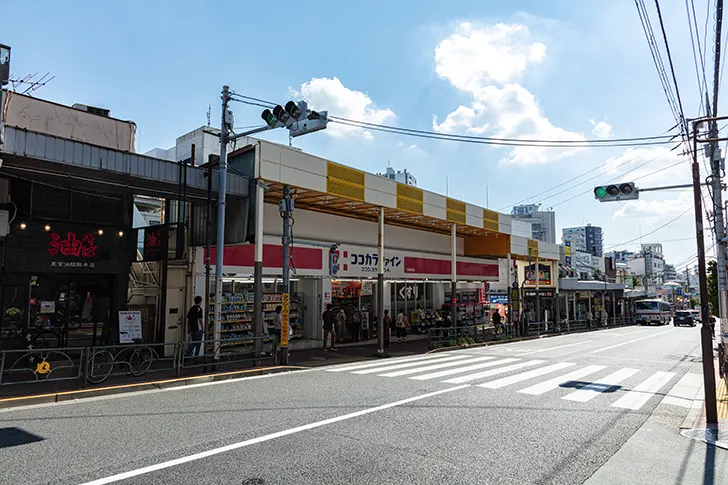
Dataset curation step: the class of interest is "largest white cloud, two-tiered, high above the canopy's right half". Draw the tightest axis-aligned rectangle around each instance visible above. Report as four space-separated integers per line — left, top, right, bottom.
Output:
432 23 585 165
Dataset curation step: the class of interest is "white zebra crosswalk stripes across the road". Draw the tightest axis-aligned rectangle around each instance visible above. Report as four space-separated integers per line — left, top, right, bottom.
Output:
325 348 702 411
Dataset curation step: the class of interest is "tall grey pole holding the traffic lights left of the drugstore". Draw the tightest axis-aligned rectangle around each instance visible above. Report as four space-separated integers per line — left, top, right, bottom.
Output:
213 86 230 358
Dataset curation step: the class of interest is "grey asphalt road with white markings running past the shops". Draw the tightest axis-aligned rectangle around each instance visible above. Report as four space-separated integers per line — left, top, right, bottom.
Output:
0 326 728 485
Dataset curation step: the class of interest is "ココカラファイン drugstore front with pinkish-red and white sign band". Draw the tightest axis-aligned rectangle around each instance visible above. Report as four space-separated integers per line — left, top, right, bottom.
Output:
200 236 499 348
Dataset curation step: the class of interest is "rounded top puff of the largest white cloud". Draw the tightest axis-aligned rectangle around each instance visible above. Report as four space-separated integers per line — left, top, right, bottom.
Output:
435 22 546 92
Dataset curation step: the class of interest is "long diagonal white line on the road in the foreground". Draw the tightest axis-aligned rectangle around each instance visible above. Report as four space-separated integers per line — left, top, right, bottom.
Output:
81 385 470 485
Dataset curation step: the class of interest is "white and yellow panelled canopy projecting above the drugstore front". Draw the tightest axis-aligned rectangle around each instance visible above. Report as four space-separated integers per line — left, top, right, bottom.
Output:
247 138 559 260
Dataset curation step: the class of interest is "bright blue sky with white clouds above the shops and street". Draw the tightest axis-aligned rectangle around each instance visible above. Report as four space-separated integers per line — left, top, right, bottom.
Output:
0 0 724 263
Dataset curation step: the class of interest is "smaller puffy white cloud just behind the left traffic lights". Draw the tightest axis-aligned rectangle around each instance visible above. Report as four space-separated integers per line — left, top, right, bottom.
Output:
291 77 396 140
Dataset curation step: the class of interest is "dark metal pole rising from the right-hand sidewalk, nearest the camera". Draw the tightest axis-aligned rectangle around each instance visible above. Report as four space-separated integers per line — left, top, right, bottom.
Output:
693 123 718 424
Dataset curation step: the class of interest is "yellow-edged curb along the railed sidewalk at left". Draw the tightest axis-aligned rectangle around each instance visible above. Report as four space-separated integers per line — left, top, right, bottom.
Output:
0 366 307 409
